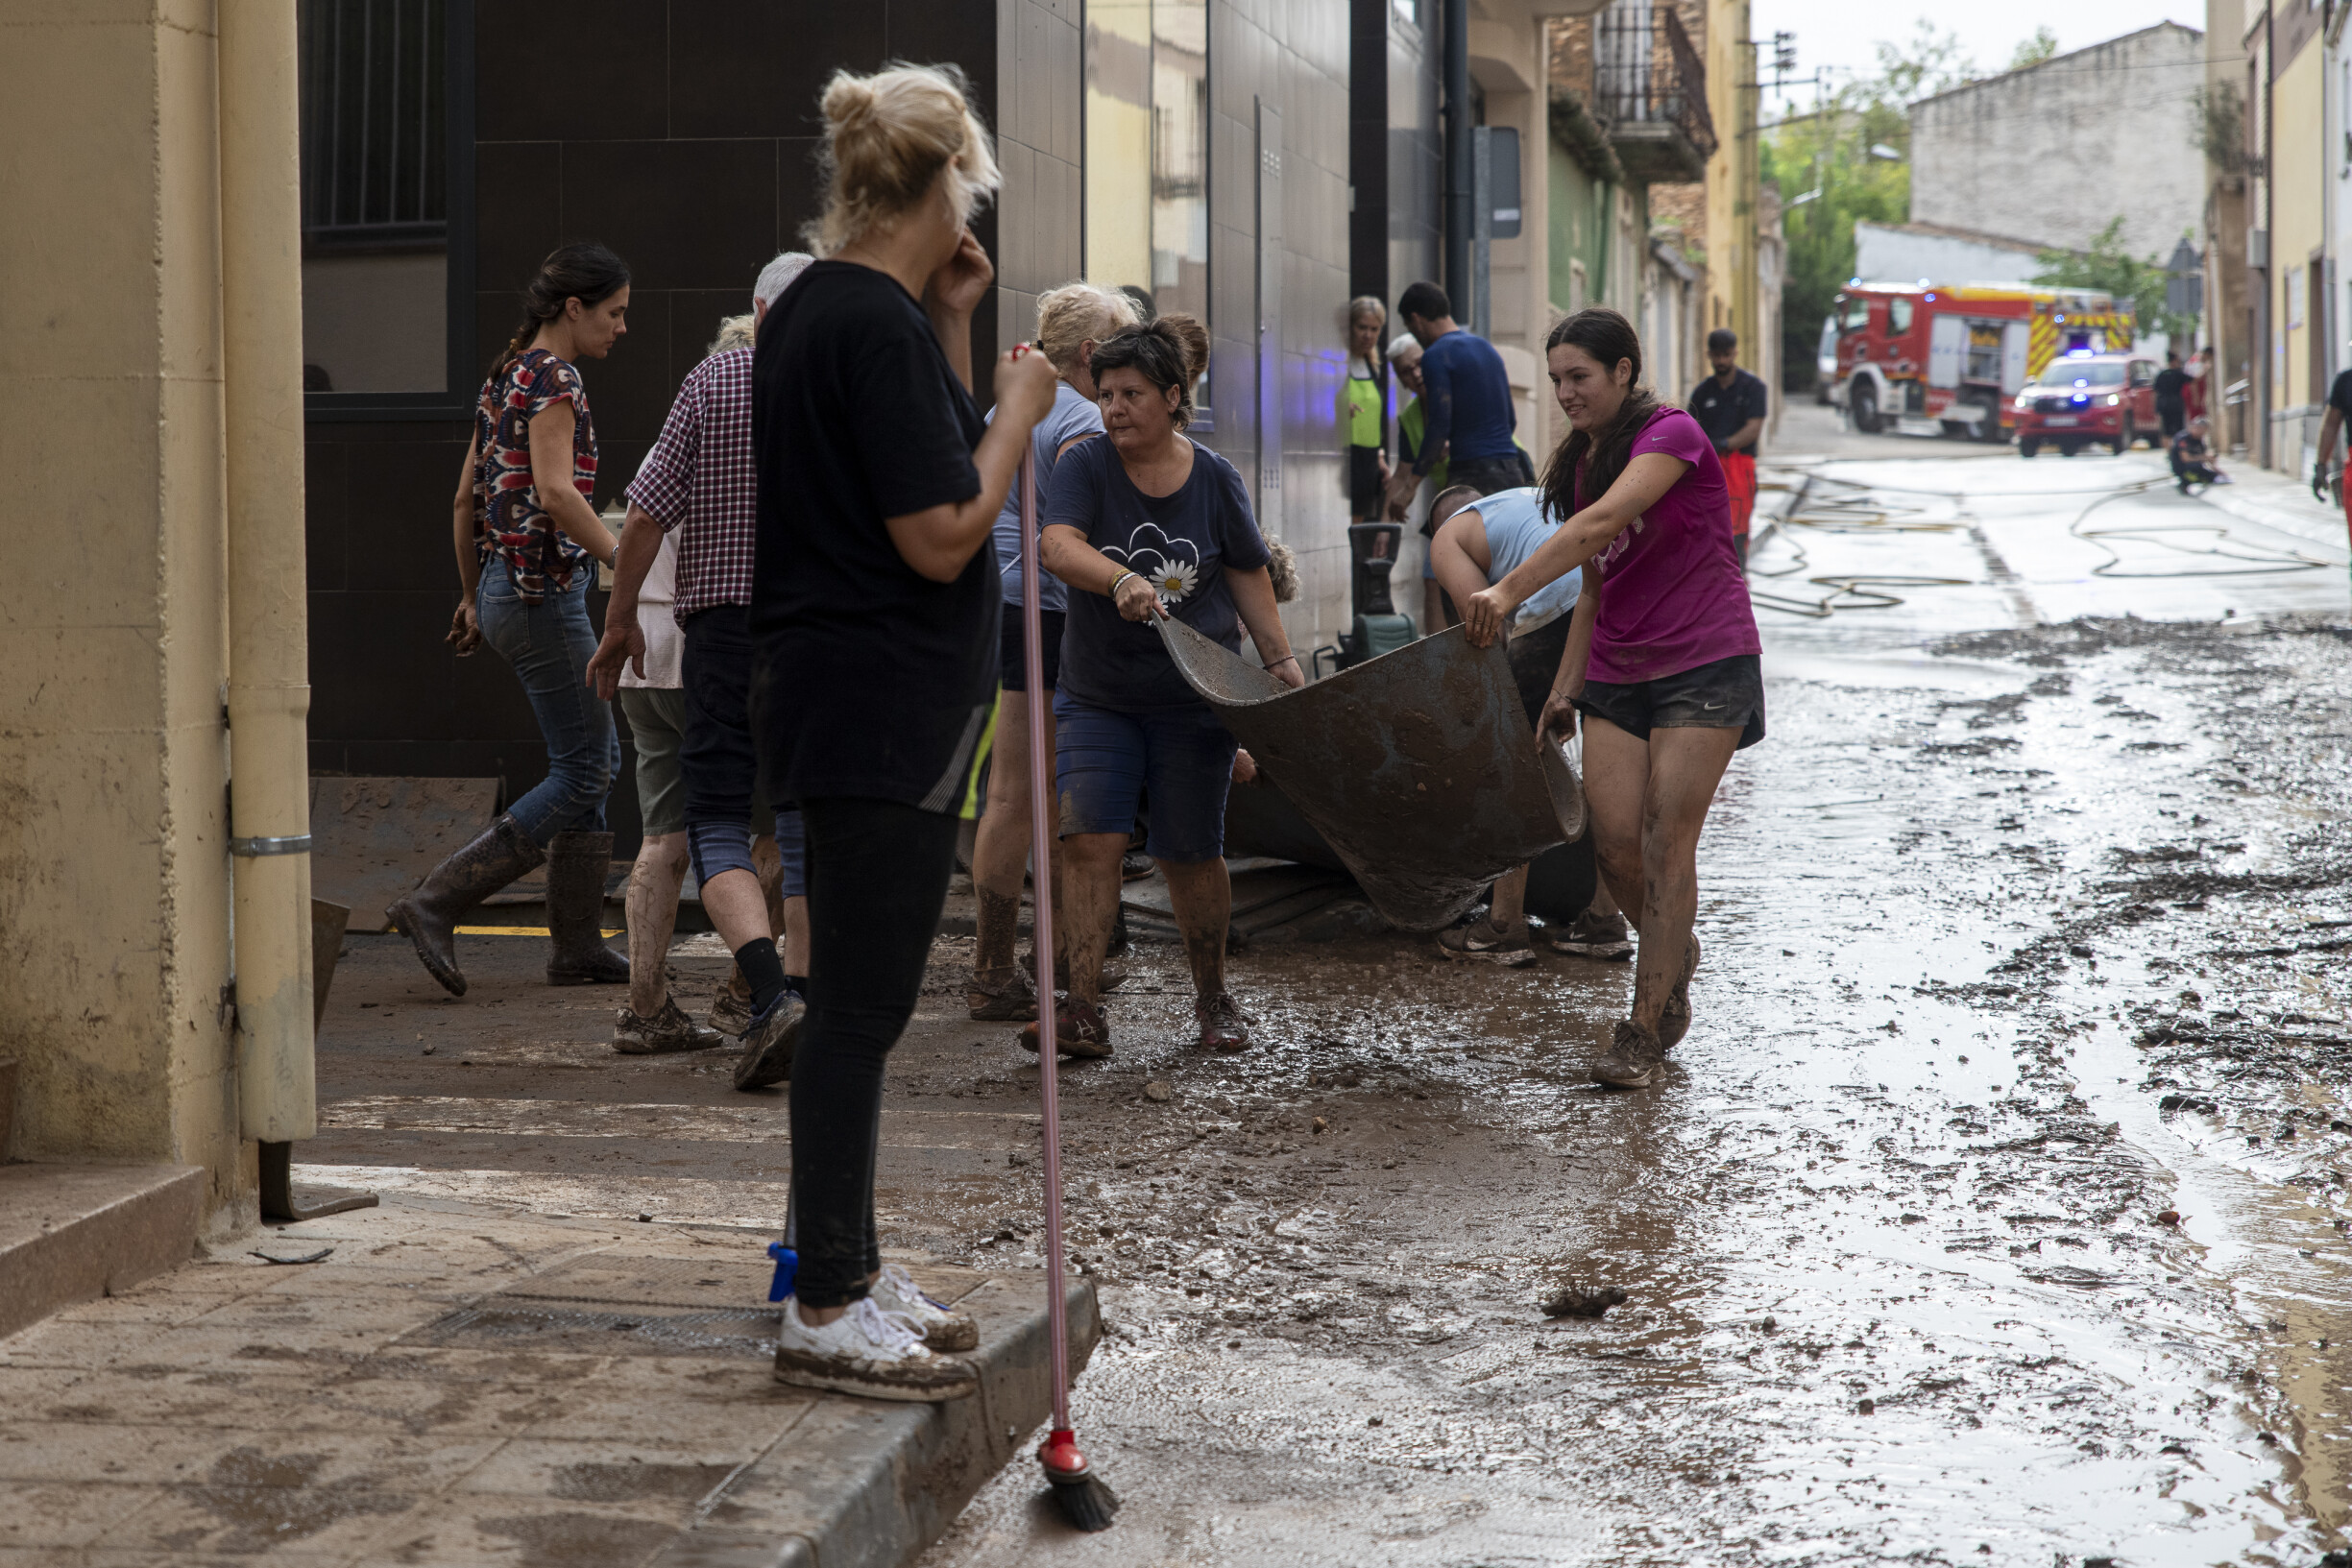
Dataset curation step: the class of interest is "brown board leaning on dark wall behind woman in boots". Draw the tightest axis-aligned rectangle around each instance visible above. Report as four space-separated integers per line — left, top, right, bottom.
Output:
310 778 498 931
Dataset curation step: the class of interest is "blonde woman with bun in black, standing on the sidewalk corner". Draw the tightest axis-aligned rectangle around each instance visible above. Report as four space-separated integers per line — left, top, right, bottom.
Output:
750 66 1056 1401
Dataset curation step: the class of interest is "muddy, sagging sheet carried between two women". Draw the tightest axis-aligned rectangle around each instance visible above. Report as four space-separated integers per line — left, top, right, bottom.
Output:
1157 620 1586 931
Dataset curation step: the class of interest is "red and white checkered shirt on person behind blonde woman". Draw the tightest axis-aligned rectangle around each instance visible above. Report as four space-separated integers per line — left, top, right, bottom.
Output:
628 348 758 623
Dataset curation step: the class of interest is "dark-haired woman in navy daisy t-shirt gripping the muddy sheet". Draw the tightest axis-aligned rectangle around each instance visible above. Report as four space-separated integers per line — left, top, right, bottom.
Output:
1044 315 1305 1055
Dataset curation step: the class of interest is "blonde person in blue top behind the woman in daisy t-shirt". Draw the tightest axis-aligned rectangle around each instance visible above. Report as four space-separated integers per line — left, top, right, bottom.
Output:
964 282 1136 1023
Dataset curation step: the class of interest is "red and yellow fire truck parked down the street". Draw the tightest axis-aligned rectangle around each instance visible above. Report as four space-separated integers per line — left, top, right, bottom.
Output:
1830 282 2133 442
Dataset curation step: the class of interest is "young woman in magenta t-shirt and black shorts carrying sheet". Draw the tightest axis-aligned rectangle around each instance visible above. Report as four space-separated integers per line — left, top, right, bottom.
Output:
1463 305 1764 1089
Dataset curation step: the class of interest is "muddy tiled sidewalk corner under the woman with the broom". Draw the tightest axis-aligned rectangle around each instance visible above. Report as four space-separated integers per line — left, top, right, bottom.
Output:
0 1192 1099 1568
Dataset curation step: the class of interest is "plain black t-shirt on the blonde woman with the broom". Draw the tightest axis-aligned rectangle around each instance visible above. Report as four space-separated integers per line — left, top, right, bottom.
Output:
750 261 1005 813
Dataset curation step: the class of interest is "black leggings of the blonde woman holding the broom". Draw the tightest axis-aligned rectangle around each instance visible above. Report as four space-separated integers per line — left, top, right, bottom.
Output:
792 797 958 1307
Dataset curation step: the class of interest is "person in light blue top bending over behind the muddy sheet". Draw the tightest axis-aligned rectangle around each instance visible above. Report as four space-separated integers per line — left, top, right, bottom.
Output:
1430 484 1633 969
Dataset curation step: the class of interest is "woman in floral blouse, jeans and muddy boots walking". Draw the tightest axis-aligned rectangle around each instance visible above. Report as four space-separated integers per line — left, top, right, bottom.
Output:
388 245 628 997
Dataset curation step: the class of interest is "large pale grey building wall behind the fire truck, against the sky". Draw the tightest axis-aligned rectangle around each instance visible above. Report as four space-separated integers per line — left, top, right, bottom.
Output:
1912 21 2204 261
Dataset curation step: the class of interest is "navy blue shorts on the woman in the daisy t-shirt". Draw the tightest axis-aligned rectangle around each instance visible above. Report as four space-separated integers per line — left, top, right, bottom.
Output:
1054 696 1235 865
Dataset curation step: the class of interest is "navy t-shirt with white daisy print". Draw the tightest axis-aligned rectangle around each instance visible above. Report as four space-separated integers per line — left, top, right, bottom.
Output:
1044 437 1268 712
